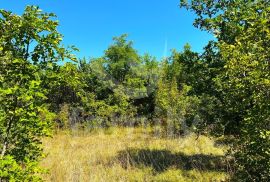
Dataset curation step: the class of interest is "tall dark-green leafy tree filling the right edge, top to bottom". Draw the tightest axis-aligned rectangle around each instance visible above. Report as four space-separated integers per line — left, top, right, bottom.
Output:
181 0 270 181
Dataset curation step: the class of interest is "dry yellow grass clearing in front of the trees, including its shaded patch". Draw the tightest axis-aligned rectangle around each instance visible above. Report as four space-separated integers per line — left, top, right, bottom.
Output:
42 128 230 182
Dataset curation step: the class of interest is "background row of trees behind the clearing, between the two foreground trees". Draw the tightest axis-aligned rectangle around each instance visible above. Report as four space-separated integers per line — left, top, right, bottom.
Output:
45 35 215 134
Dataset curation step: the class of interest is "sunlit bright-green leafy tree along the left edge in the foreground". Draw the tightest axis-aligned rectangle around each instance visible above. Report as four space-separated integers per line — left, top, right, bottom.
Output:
0 6 75 181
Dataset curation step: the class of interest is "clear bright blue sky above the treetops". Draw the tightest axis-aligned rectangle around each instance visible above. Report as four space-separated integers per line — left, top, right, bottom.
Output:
0 0 213 59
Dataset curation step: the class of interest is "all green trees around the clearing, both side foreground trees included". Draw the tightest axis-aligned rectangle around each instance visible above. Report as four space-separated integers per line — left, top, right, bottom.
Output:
0 0 270 181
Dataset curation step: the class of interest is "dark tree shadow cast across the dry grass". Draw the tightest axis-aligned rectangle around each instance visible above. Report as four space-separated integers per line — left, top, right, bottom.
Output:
117 149 230 173
